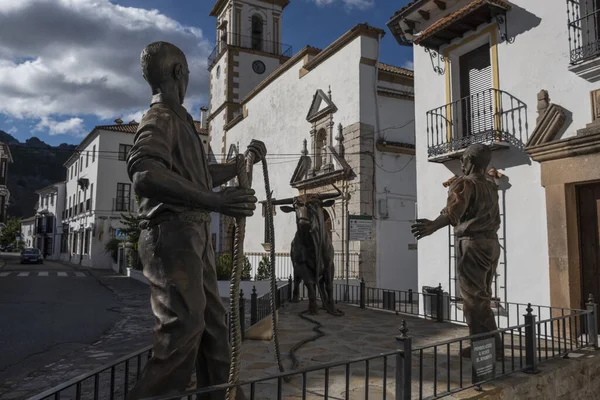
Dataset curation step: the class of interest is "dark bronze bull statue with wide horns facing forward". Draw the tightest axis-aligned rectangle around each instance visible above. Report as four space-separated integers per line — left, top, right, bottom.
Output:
273 186 342 315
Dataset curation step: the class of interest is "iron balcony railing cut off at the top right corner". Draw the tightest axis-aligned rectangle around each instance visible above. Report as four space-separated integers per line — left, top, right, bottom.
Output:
567 0 600 64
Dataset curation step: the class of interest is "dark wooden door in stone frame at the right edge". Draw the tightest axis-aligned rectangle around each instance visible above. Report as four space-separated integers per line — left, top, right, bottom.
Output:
577 182 600 326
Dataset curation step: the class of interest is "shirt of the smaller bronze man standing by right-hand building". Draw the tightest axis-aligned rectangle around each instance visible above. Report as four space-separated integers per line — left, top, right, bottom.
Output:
442 174 500 238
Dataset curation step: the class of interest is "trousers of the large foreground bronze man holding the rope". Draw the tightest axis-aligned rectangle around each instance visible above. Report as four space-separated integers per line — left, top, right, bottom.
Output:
127 219 245 400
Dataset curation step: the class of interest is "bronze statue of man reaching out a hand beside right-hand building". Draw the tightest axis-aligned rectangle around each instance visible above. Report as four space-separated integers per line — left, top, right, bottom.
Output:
412 144 503 358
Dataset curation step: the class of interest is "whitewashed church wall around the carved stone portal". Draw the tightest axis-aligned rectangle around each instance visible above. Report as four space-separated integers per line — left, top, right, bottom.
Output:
226 37 367 252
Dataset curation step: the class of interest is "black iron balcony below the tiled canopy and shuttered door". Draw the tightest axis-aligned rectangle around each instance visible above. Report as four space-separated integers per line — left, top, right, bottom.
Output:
427 89 528 163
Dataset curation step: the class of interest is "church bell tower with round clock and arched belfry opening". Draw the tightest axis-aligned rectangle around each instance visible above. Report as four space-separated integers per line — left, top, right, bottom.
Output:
208 0 292 161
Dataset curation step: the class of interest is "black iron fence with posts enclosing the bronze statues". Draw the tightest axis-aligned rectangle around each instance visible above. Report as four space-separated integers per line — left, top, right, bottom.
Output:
31 280 598 400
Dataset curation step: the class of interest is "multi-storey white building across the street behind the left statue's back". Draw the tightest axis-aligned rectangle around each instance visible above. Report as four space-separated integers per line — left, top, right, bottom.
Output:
61 119 208 268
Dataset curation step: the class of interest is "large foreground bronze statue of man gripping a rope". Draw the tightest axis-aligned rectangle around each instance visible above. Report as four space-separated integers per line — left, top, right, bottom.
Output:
127 42 266 399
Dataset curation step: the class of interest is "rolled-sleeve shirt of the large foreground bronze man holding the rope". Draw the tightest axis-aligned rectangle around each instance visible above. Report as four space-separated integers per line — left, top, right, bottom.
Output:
127 94 212 219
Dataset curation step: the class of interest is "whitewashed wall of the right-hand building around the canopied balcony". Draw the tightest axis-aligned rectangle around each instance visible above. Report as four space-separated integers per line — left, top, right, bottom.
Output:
414 0 600 304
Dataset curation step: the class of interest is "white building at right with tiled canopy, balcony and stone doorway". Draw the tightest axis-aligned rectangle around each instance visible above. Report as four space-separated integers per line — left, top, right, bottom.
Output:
388 0 600 316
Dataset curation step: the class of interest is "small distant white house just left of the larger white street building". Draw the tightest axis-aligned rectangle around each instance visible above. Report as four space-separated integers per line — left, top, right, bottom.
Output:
33 182 66 260
